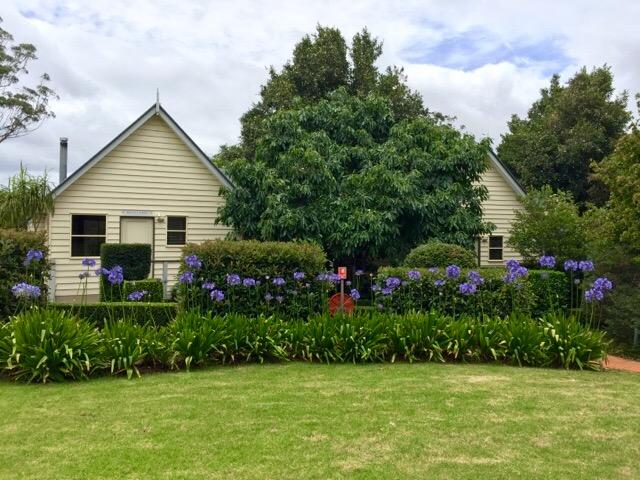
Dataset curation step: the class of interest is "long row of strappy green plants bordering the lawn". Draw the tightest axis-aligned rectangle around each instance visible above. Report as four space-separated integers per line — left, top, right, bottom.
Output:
0 310 608 382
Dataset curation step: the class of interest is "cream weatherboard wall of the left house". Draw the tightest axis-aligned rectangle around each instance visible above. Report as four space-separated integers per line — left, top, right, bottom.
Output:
48 116 229 300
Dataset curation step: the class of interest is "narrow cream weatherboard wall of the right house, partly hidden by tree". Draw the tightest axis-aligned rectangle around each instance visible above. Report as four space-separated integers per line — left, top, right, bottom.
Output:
476 162 521 267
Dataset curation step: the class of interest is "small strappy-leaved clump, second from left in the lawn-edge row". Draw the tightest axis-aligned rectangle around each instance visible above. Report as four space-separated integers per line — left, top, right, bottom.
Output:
100 319 149 379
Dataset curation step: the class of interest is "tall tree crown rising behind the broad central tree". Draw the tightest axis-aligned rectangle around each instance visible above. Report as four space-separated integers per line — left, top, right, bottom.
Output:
228 26 444 163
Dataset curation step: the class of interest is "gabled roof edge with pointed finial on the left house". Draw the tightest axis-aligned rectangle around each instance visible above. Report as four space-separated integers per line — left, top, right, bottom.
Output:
53 102 233 197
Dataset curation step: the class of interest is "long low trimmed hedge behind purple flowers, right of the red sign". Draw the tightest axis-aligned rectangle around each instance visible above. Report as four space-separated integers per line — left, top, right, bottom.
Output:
372 267 570 317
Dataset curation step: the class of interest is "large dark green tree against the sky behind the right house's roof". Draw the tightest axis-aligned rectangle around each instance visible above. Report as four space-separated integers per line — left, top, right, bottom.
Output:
498 66 631 205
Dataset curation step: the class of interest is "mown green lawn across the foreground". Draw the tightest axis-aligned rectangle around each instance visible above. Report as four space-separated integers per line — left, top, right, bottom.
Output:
0 363 640 480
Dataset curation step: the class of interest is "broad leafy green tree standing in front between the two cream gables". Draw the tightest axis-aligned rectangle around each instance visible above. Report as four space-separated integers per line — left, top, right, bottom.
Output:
220 90 489 259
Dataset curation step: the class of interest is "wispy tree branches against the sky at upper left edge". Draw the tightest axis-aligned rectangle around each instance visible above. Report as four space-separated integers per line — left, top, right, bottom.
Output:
0 18 57 143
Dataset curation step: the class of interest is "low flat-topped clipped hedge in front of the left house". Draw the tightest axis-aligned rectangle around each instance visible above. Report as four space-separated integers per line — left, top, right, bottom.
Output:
49 302 178 327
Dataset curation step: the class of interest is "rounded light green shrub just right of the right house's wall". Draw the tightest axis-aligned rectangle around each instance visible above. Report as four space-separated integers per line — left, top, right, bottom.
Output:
507 186 587 264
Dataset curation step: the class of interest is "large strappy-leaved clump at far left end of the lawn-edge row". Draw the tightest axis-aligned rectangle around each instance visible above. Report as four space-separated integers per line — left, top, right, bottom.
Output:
2 308 100 383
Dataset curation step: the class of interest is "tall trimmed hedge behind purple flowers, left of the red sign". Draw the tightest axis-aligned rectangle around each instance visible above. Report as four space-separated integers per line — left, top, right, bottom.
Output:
177 240 335 318
